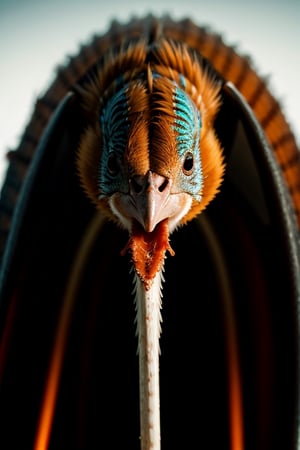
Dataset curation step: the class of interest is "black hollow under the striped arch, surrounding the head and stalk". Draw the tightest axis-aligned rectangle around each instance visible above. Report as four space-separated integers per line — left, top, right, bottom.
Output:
0 74 299 450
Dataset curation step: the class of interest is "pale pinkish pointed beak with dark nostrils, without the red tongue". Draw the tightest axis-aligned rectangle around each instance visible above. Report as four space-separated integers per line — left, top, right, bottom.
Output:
130 171 172 232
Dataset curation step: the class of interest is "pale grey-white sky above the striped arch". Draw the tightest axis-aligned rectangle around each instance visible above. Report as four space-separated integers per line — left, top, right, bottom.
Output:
0 0 300 182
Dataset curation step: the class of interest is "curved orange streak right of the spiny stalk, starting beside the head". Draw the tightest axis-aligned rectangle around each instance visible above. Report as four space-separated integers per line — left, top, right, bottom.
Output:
197 215 245 450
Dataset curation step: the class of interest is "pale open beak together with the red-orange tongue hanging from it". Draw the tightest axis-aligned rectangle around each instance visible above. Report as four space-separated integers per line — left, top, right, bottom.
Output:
116 171 192 289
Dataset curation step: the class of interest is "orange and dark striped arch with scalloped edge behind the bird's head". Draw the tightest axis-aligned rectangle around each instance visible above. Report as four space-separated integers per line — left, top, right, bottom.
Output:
0 16 300 253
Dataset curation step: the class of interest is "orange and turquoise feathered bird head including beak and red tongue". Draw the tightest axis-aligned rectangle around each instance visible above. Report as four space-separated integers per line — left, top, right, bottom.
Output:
78 39 224 288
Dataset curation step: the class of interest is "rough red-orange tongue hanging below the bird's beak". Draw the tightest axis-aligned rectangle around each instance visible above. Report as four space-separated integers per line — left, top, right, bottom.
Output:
121 219 174 290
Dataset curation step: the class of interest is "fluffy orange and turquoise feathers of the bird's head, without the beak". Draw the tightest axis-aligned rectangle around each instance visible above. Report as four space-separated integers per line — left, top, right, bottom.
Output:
77 38 224 223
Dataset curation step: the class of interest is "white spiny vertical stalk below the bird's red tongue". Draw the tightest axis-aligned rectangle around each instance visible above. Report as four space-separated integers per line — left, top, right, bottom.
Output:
135 271 163 450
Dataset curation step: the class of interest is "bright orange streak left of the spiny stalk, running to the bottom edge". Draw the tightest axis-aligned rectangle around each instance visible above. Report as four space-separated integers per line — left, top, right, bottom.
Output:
34 215 103 450
